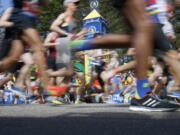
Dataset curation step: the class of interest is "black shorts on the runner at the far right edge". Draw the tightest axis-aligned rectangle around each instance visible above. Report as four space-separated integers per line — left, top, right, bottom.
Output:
154 24 174 52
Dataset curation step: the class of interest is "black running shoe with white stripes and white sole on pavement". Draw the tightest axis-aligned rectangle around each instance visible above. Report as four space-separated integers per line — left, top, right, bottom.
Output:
129 94 180 112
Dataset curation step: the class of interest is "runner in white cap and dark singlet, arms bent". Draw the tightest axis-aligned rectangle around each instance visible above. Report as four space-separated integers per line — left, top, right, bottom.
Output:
48 0 86 103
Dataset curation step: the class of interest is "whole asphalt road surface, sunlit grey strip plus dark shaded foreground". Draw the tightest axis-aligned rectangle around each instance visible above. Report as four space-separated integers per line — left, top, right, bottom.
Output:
0 104 180 135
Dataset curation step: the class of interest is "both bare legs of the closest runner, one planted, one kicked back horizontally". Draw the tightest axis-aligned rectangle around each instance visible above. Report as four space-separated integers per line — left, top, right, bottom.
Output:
72 0 154 79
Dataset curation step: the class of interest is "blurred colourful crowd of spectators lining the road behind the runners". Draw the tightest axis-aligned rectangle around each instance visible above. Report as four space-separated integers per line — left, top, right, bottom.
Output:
0 50 180 104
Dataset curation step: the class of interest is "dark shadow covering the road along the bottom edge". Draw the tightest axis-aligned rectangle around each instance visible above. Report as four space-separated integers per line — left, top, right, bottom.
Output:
0 112 180 135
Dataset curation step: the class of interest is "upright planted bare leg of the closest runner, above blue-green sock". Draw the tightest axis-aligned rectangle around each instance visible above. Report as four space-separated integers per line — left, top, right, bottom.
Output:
125 0 154 79
